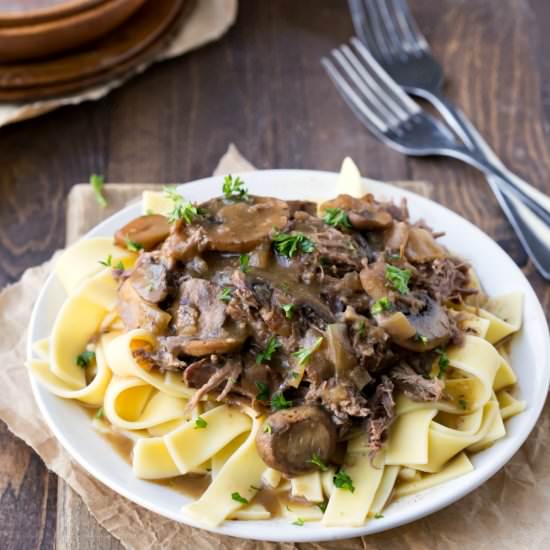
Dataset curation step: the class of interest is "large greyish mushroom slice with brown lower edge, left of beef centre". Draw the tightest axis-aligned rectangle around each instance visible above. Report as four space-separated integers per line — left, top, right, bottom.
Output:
174 279 248 357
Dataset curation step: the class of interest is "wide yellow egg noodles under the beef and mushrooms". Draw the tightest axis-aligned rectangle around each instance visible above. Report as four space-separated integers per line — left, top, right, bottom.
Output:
28 161 525 526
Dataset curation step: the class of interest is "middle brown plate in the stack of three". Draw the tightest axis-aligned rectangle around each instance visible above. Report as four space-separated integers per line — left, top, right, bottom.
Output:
0 0 145 62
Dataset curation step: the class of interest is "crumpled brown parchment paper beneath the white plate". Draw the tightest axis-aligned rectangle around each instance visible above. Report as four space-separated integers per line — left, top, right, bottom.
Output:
0 146 550 550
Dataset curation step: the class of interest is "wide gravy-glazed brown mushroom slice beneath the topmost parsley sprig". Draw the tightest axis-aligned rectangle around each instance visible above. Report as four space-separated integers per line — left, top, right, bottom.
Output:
201 197 288 252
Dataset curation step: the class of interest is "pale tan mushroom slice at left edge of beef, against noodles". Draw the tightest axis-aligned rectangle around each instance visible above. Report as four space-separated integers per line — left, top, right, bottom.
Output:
116 279 171 334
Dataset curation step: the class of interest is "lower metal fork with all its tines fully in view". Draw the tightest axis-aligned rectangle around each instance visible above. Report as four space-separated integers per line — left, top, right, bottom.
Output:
321 38 550 280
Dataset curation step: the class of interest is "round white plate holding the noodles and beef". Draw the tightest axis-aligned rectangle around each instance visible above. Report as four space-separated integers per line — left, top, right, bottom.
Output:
27 170 550 542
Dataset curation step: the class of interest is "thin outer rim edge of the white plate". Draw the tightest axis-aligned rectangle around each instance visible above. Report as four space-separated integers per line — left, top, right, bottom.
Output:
27 169 550 542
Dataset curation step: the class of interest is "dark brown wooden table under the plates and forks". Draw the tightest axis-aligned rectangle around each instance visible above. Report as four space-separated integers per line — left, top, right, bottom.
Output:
0 0 550 550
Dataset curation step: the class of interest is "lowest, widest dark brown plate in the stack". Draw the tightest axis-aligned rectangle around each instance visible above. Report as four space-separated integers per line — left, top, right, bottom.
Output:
0 0 190 102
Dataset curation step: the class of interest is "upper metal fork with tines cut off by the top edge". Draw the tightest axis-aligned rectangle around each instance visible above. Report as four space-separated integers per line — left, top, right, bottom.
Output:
348 0 550 279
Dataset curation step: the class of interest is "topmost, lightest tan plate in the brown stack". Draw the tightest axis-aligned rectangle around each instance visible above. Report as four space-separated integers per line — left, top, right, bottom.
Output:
0 0 106 27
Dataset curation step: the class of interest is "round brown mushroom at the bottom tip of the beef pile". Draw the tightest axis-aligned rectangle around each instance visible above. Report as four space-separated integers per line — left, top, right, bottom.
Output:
256 405 336 477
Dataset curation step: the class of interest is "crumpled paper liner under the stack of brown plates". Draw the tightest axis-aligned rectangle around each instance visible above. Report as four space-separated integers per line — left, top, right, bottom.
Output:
0 0 238 127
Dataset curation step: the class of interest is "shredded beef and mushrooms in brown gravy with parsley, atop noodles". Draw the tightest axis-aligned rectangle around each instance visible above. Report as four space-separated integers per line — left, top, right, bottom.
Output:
115 177 476 477
